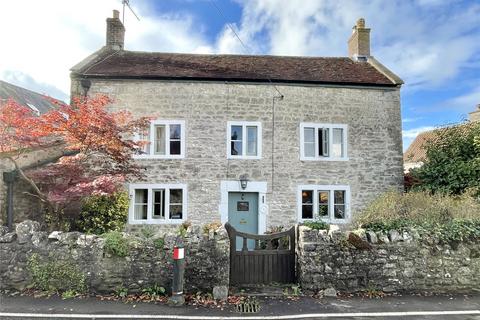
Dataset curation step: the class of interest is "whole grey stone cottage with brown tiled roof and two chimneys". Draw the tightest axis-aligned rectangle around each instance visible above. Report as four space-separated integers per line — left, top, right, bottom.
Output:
71 11 403 233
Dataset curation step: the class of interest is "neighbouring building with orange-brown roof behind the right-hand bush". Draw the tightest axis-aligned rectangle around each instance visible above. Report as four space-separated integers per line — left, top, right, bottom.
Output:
403 104 480 173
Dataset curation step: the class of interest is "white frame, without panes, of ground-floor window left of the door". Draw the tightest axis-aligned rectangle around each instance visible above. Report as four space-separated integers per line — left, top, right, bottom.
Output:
128 183 188 224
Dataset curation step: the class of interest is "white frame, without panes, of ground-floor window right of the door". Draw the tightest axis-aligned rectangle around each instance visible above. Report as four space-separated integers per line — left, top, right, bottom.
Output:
297 184 350 224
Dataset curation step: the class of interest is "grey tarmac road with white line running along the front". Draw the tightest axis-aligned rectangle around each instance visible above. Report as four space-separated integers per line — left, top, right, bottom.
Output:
0 294 480 320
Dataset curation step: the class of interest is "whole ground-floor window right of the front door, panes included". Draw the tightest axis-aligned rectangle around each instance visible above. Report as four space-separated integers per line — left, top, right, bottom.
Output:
297 185 350 223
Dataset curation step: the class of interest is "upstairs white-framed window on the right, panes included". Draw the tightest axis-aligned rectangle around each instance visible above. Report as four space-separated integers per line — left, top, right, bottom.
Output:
300 123 348 161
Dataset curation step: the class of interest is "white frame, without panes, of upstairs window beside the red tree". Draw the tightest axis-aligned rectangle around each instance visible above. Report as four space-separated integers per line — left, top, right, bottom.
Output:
133 119 186 159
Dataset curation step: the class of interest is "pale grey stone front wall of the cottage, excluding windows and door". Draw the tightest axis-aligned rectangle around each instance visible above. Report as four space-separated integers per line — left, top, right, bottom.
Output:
71 76 403 228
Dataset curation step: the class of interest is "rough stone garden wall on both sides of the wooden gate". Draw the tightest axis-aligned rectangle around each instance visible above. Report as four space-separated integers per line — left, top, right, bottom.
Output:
0 220 480 293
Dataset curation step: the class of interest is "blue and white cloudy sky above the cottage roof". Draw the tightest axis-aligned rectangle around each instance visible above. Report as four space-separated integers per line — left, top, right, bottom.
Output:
0 0 480 149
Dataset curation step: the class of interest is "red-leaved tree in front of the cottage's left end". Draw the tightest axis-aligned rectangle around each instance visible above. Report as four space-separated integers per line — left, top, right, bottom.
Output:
0 95 149 226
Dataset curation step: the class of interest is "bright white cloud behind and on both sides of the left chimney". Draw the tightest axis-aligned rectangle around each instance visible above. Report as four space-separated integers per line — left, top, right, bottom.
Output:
0 0 213 99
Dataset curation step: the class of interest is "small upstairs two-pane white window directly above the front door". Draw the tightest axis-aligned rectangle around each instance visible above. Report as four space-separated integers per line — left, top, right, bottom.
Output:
227 121 262 159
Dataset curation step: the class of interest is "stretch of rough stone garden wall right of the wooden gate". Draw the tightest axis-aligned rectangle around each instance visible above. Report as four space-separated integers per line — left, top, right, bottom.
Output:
297 226 480 292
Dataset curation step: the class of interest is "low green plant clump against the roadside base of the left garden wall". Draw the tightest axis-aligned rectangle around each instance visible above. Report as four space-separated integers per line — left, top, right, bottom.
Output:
27 253 87 296
